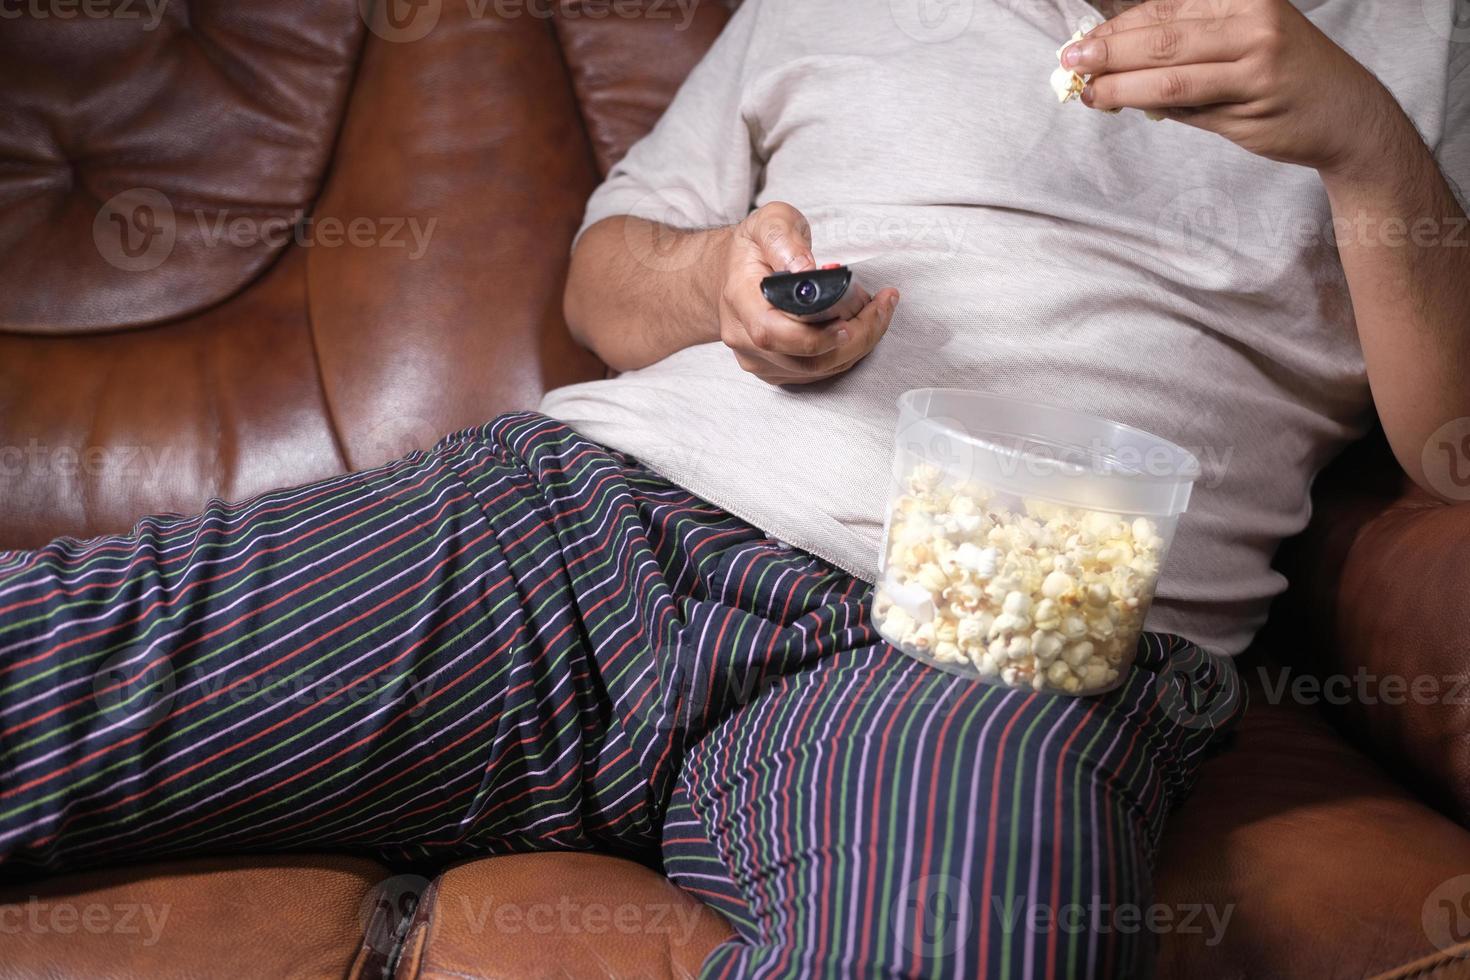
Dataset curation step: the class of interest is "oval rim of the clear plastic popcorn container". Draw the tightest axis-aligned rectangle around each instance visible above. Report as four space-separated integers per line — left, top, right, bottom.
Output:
898 386 1202 485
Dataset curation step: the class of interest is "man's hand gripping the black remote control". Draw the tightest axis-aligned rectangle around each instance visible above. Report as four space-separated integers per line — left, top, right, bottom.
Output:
719 203 898 385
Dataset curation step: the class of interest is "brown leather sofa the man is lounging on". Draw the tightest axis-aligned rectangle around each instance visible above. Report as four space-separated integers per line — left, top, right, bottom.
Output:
0 0 1470 979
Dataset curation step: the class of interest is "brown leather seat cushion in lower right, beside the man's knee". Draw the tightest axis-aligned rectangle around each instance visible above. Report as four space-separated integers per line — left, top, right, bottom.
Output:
1155 669 1470 980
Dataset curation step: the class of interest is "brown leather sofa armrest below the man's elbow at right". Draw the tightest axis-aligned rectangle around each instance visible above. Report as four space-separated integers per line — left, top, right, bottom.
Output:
1261 436 1470 824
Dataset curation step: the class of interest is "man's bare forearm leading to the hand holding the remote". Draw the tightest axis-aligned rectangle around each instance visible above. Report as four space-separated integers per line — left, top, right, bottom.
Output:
564 217 732 370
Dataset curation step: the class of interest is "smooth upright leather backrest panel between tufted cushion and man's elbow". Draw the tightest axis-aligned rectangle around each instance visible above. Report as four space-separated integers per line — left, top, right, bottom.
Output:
304 3 603 467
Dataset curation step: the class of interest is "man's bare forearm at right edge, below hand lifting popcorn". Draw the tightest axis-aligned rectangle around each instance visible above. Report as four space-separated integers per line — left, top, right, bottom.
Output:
1322 91 1470 485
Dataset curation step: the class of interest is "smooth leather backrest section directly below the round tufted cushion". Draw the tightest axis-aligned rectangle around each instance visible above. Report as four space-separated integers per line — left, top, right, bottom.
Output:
0 250 344 548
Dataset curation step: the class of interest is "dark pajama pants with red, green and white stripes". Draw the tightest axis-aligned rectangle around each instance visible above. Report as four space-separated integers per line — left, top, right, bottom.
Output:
0 413 1241 977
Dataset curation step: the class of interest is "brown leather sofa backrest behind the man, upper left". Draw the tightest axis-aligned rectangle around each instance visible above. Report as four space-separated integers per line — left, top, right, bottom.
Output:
0 0 728 548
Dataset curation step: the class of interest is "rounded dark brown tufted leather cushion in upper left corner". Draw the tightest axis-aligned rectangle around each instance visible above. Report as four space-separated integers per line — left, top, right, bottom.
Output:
0 0 363 334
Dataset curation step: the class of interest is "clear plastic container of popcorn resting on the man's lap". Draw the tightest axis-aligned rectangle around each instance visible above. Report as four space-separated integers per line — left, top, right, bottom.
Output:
873 388 1200 695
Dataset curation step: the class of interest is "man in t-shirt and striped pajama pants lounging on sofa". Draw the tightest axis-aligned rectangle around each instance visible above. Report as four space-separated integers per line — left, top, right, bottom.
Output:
0 0 1470 976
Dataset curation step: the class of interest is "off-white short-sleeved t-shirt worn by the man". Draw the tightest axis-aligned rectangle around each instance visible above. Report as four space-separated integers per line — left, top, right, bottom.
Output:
541 0 1470 652
